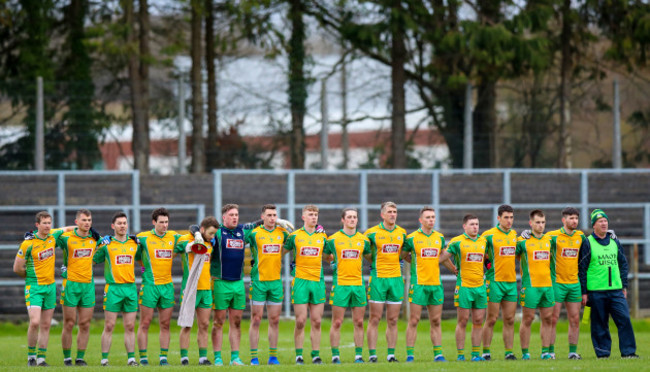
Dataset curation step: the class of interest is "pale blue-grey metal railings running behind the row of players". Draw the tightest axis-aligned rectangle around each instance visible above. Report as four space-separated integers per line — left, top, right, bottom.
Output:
0 169 650 316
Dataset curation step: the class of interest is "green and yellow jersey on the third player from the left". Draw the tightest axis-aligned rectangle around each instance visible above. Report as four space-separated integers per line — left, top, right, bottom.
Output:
93 236 138 284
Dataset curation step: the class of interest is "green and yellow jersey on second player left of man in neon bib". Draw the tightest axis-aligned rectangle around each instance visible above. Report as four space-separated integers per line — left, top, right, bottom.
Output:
515 234 555 288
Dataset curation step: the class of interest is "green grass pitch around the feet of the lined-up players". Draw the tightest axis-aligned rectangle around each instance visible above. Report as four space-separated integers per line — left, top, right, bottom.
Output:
0 319 650 372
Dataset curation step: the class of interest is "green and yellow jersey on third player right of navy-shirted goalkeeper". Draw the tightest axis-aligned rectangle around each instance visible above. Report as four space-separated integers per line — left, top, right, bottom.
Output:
324 230 370 285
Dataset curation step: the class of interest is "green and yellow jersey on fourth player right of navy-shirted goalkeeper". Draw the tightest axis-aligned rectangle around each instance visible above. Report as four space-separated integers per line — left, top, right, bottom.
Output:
365 222 406 278
